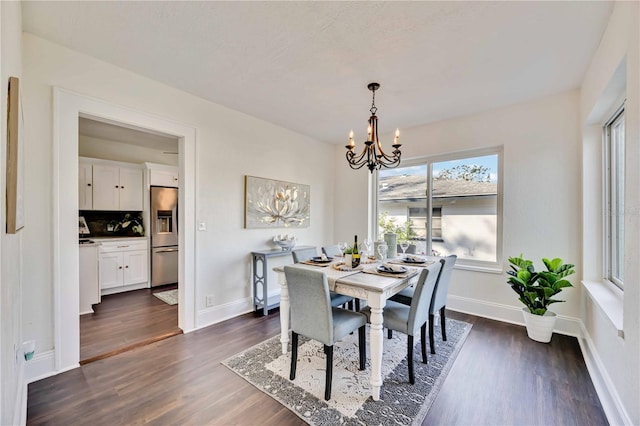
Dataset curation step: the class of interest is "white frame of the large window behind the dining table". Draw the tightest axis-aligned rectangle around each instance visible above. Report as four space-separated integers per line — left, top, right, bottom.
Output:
370 145 504 273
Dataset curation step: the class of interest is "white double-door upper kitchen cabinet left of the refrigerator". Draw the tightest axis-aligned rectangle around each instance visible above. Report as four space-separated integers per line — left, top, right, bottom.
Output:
93 164 143 211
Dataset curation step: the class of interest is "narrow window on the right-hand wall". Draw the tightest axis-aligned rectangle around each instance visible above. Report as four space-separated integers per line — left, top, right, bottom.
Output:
604 108 625 288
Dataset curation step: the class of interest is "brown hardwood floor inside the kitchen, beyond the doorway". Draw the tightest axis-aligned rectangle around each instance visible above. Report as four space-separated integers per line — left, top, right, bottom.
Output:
80 285 182 364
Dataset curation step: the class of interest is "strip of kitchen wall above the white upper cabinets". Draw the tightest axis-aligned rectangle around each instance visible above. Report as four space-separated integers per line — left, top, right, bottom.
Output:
78 135 178 166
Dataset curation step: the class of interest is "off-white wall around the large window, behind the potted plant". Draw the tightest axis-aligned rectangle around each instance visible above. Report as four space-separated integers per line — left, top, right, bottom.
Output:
334 91 582 328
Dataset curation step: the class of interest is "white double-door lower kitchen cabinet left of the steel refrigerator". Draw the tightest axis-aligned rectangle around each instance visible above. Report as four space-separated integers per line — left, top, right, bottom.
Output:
99 239 149 294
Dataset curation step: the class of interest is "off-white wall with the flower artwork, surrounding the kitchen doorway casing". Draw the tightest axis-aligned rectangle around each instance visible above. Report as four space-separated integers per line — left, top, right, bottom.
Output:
23 34 334 366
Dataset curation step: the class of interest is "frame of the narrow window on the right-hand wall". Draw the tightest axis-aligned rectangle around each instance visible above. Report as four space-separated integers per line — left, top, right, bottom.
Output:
602 101 626 290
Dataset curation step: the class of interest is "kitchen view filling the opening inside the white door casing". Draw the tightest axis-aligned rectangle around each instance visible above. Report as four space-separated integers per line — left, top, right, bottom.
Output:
78 116 182 364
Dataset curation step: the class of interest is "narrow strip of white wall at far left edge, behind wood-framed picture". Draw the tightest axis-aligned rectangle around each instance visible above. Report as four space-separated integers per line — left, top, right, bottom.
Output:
0 2 25 425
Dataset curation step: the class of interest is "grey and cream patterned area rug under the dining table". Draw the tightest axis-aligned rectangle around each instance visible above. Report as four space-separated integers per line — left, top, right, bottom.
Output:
222 318 471 426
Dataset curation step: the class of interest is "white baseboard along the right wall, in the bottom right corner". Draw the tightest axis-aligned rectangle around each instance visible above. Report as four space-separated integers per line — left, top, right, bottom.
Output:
578 322 633 425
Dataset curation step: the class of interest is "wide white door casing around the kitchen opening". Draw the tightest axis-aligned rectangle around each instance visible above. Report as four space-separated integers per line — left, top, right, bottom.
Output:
53 88 196 372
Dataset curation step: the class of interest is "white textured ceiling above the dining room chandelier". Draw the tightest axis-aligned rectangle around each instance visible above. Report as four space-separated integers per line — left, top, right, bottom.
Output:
22 1 613 144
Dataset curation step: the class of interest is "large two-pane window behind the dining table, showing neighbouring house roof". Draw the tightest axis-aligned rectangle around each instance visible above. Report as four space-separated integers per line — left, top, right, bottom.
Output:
377 148 502 266
